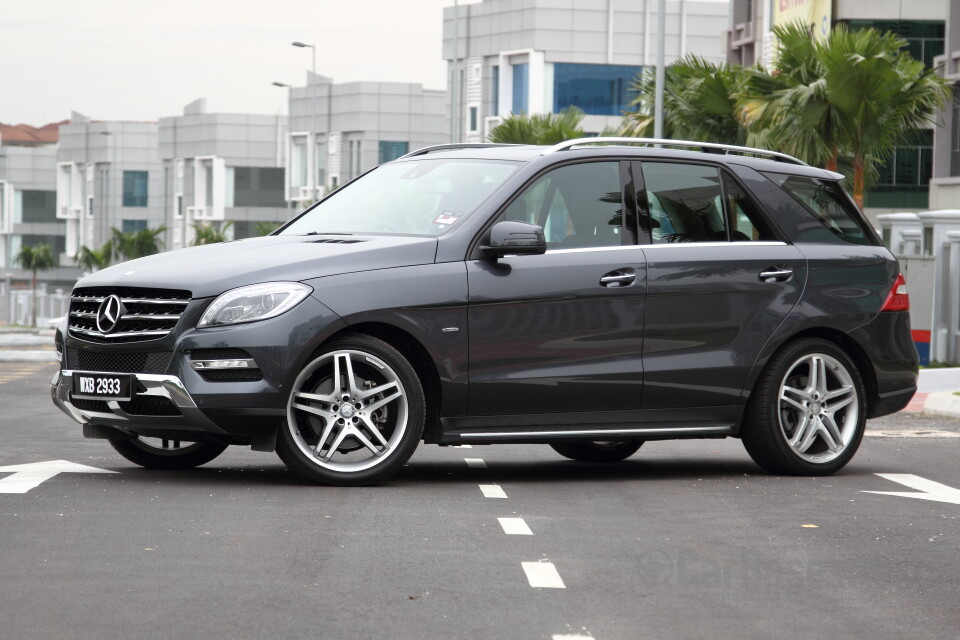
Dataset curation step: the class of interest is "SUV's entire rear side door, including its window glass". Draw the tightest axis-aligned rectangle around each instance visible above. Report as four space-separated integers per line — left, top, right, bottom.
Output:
636 161 807 409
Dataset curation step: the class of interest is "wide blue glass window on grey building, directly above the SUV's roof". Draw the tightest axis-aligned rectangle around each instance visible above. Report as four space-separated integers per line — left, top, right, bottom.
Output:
553 62 643 116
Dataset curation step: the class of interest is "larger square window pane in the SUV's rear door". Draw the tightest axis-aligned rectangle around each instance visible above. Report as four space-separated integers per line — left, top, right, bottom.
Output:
643 162 727 244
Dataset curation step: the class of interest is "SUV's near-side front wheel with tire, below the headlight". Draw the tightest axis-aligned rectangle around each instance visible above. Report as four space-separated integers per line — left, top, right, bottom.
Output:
277 335 426 486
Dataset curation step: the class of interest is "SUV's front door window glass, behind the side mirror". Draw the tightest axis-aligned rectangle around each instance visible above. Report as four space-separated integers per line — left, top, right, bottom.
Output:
505 162 623 249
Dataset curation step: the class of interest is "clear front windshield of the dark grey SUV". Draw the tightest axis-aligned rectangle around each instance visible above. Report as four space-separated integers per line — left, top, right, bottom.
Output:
280 158 519 236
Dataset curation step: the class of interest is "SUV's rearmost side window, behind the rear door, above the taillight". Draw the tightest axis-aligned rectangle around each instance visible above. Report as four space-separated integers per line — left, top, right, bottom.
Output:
764 173 876 245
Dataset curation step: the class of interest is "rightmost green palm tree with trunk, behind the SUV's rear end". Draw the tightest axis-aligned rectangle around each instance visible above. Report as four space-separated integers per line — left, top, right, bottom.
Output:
821 25 949 209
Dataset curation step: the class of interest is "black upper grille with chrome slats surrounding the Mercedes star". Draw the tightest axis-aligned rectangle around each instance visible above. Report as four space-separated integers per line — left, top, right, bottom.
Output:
69 287 190 343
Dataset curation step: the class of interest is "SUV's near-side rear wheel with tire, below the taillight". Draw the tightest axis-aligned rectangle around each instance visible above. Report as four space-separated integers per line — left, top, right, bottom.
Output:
740 338 867 476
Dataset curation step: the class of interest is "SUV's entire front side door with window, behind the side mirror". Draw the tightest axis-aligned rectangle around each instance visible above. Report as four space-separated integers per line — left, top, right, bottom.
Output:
467 160 646 416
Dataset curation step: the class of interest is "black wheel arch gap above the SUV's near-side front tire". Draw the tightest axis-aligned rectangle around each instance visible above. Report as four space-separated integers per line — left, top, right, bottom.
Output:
320 322 443 442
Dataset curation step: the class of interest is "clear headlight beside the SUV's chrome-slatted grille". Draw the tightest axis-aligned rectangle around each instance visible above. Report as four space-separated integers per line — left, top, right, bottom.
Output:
197 282 313 329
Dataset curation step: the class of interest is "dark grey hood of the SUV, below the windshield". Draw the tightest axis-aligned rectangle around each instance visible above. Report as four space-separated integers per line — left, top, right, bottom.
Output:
77 235 437 298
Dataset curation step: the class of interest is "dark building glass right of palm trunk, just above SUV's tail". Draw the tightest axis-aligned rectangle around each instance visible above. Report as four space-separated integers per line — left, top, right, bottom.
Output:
863 129 933 209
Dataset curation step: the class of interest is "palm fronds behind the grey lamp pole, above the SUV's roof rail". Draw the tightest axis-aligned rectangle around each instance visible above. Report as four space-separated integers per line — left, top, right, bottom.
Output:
622 55 746 144
